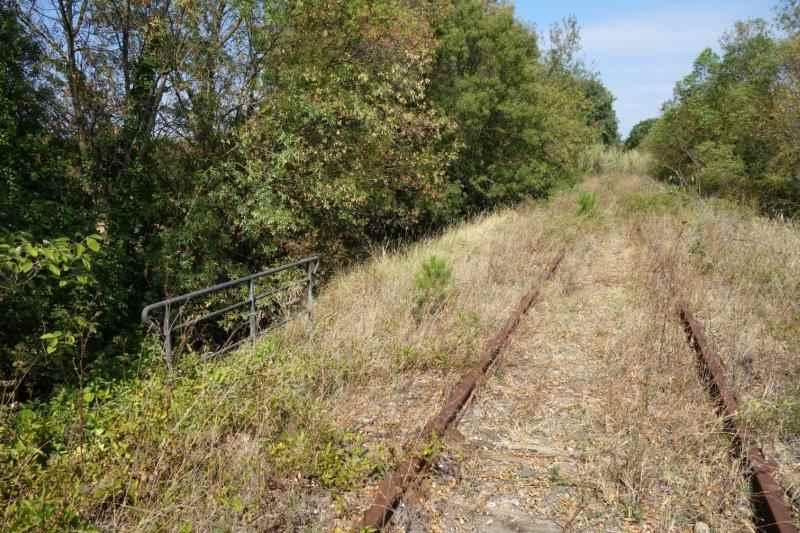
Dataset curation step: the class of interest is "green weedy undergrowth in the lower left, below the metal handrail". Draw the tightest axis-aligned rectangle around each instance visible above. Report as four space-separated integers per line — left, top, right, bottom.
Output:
0 339 376 531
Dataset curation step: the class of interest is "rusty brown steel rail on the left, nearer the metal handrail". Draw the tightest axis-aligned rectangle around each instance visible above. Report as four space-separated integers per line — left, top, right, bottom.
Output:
356 250 565 531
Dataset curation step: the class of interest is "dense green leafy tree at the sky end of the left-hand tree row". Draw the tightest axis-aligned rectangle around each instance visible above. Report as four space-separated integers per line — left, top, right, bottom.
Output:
431 0 589 211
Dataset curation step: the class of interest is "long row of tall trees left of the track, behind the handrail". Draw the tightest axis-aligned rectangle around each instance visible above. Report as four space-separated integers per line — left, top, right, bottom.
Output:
0 0 617 399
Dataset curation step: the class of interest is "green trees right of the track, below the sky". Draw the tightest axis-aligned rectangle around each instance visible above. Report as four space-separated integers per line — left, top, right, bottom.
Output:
644 0 800 216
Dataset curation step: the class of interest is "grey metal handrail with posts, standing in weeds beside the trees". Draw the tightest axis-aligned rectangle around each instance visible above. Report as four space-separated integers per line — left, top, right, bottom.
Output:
142 255 320 371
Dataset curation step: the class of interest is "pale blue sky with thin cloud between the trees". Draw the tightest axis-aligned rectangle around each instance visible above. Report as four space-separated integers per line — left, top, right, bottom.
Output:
512 0 777 136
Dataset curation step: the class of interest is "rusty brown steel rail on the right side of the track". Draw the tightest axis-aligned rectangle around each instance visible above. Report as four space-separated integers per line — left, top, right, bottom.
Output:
678 302 797 533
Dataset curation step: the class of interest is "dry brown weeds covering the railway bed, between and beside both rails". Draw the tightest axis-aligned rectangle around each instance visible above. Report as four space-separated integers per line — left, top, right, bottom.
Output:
111 172 800 533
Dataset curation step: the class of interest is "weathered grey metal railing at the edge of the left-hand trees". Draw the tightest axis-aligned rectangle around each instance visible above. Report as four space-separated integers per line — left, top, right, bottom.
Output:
142 255 320 371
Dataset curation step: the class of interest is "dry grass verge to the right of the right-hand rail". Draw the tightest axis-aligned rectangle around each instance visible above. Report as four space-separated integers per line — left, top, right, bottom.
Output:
620 176 800 511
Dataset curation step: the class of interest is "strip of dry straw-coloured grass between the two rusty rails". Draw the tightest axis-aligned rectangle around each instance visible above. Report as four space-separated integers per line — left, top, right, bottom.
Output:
390 177 751 532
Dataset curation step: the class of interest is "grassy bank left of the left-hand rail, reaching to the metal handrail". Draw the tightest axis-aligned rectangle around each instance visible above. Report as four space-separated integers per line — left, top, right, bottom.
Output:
81 196 576 531
